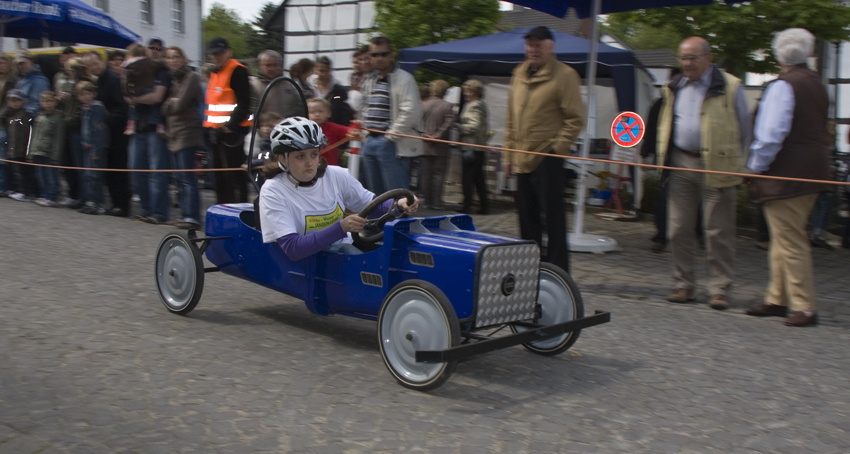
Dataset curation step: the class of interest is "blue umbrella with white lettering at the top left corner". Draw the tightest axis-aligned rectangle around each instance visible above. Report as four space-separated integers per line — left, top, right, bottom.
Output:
0 0 141 47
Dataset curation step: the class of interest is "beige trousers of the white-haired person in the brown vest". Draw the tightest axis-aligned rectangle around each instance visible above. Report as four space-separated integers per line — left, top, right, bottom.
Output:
764 194 818 311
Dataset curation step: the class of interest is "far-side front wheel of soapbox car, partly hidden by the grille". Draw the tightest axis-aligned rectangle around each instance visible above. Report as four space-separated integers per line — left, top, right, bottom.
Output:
511 262 584 356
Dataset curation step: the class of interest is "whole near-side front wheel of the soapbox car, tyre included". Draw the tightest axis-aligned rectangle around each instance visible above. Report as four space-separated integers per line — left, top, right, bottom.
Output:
378 279 460 391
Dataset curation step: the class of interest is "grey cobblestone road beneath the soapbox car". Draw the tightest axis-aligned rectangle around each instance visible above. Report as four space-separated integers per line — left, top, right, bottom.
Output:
0 196 850 454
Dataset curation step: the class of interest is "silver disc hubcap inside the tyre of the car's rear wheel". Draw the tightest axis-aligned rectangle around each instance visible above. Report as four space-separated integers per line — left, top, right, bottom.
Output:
156 238 196 309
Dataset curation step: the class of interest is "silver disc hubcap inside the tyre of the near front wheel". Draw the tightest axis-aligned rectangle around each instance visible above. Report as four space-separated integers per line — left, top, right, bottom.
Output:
380 289 450 383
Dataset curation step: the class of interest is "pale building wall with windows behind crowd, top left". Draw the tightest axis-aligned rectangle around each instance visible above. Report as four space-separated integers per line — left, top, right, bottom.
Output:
3 0 203 63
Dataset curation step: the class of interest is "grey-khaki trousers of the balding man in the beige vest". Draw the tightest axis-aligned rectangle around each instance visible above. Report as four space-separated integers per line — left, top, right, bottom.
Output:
668 149 737 295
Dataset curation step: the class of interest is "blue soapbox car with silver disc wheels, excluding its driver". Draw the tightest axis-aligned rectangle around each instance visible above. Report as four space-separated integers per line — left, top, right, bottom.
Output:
155 78 610 391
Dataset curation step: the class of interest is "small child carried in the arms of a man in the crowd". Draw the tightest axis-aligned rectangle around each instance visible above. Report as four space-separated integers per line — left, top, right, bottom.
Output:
121 44 165 135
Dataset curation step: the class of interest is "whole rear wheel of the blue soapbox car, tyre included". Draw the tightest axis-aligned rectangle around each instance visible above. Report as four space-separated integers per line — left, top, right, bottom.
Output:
156 232 204 315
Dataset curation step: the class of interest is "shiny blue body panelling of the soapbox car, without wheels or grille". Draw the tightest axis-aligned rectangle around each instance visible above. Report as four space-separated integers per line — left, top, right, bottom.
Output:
205 204 520 322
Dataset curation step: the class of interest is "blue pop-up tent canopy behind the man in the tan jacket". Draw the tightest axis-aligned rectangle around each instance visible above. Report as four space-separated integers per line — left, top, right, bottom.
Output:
399 27 640 110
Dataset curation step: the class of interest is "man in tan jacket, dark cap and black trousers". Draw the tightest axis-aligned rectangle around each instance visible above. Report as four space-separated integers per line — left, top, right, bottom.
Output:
505 26 585 272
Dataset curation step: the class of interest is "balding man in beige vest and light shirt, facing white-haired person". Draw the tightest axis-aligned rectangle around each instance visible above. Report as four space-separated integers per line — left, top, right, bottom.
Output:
657 37 752 310
